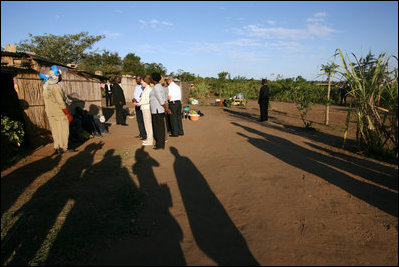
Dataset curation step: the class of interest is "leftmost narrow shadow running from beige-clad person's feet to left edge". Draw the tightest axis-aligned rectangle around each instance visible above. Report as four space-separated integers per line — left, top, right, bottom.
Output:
1 155 61 216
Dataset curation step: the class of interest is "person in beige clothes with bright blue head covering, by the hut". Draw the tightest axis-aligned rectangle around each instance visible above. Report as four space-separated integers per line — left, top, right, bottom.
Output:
39 65 73 154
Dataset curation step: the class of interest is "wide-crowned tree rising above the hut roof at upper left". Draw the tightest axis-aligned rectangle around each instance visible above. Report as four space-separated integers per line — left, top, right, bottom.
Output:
17 32 105 64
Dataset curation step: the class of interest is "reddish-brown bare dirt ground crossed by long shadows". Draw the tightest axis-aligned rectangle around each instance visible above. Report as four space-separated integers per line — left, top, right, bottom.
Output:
1 100 398 266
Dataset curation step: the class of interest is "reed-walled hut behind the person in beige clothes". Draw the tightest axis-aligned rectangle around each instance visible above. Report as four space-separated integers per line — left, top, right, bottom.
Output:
1 51 106 146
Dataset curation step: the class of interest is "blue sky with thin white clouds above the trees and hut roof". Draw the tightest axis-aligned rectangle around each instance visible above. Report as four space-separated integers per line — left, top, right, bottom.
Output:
1 1 398 80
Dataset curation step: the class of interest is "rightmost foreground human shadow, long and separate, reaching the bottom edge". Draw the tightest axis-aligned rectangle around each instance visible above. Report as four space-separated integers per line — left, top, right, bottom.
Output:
170 147 259 266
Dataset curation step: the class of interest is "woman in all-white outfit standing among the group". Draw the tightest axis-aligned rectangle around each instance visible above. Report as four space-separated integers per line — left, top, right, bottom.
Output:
138 75 154 146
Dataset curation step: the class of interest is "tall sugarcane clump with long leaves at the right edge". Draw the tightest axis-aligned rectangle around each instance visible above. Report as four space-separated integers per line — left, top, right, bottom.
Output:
336 49 398 160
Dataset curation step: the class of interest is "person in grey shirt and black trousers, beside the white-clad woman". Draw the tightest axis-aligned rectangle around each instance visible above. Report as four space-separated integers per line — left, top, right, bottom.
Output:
150 73 171 149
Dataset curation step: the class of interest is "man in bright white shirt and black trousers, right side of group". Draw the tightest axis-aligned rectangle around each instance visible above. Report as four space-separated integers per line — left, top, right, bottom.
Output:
166 76 184 137
